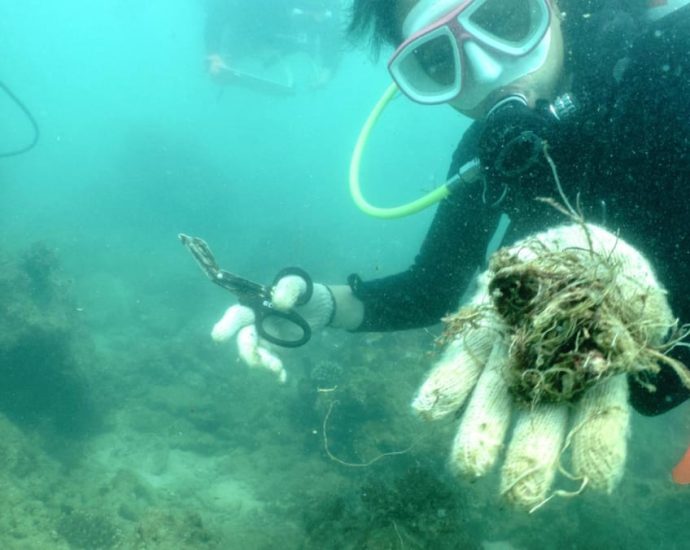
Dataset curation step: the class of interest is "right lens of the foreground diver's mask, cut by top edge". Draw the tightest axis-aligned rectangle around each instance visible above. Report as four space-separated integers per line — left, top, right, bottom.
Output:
467 0 548 46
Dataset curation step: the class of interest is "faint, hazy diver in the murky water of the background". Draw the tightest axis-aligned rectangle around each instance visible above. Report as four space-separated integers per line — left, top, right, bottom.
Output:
205 0 342 94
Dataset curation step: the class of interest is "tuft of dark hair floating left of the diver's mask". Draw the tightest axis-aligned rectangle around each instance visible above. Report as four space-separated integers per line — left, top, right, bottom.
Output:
348 0 402 55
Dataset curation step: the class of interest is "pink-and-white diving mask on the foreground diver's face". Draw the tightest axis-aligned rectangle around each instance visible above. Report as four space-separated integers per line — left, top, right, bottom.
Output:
388 0 553 110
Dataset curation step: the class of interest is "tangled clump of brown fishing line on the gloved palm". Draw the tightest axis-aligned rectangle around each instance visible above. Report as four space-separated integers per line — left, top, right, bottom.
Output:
484 229 687 404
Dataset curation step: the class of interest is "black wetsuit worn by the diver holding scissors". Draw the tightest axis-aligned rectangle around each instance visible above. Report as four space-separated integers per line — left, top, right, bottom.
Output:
349 0 690 415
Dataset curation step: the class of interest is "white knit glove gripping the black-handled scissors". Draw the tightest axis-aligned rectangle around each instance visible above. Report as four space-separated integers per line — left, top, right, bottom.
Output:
211 275 335 382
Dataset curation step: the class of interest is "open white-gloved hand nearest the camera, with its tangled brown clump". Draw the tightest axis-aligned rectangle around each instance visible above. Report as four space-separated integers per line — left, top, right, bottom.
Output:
412 225 678 510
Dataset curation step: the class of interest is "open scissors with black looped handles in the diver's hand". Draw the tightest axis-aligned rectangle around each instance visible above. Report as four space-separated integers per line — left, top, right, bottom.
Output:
178 233 314 348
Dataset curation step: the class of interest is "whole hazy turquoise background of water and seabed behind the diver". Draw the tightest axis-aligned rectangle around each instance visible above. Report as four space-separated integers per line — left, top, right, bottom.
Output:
0 0 690 549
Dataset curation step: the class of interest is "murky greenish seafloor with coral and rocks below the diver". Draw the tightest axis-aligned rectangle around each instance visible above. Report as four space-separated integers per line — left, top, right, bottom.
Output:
0 244 690 549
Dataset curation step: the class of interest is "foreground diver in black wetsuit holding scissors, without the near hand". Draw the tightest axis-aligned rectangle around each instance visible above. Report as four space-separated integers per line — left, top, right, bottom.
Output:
207 0 690 422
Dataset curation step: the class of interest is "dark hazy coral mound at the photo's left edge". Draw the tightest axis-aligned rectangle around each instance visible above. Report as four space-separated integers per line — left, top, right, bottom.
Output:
0 243 97 436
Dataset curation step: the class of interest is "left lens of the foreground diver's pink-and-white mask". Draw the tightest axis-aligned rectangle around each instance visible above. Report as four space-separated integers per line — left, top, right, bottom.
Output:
391 29 460 99
